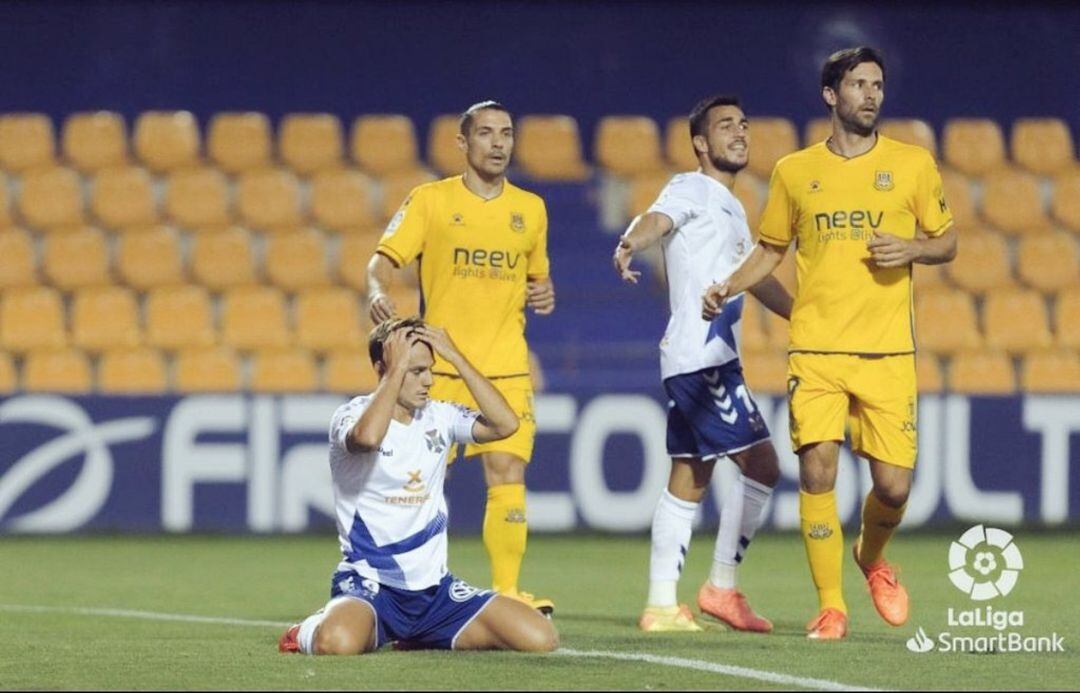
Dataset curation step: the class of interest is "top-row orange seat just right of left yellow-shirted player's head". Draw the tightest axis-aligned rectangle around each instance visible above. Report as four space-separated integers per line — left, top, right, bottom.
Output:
514 116 590 181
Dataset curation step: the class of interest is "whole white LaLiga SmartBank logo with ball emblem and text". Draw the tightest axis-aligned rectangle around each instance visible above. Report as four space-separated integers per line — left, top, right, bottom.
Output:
907 525 1065 654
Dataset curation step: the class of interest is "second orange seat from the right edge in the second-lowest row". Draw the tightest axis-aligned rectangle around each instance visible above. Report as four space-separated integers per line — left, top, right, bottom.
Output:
983 289 1052 354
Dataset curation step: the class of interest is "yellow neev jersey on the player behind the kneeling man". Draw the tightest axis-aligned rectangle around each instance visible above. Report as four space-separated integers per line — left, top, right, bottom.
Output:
377 176 550 378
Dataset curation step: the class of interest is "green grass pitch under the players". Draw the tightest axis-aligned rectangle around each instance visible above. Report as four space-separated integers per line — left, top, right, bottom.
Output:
0 531 1080 690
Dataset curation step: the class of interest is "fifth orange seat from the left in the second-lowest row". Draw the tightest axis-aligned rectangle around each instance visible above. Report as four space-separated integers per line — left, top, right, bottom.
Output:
296 286 370 353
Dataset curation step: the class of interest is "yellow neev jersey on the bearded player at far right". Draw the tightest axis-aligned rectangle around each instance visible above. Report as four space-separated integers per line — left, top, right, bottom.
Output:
760 135 953 354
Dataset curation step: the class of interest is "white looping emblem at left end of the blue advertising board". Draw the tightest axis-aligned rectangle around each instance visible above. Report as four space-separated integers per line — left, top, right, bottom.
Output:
0 395 157 532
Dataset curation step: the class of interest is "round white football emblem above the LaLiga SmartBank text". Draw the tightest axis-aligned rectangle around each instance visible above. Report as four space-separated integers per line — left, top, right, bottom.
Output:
948 525 1024 601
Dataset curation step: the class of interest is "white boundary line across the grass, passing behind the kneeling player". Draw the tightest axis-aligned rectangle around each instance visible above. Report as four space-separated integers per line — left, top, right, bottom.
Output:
0 604 876 691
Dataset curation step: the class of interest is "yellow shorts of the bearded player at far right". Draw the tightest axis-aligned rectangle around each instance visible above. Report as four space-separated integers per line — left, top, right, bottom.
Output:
787 353 918 470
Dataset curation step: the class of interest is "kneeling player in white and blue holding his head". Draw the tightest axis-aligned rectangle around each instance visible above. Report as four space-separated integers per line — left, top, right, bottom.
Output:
279 317 558 654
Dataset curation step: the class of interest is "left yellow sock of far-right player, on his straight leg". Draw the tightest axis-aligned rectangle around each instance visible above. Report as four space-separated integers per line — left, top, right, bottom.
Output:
799 490 848 613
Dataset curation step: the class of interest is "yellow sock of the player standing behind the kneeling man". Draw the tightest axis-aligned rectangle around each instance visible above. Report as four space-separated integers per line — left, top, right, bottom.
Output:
484 484 528 594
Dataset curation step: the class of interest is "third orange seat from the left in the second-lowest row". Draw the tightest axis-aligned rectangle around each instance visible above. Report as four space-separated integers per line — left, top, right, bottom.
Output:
144 285 217 351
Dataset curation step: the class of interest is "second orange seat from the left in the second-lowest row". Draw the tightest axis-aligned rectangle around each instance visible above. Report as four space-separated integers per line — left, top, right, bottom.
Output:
70 286 141 353
